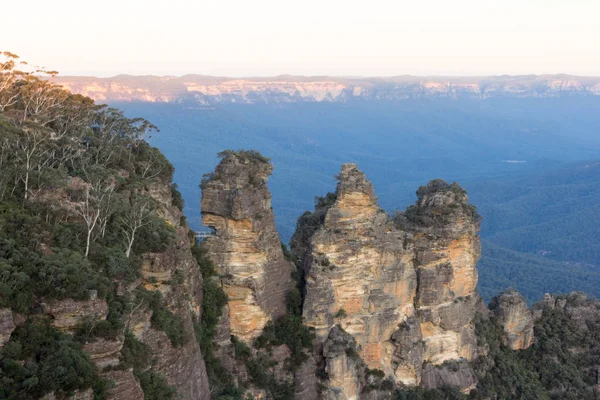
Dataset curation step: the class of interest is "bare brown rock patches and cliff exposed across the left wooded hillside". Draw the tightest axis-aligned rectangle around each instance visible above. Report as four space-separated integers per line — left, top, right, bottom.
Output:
0 183 210 400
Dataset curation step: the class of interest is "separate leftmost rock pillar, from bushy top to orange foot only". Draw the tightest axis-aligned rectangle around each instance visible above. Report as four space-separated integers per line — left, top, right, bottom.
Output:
201 151 292 343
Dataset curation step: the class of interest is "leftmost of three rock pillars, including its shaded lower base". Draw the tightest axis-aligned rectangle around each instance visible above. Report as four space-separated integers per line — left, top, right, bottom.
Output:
201 151 296 399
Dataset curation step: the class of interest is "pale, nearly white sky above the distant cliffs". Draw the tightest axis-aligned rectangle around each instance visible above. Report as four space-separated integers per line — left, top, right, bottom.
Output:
0 0 600 76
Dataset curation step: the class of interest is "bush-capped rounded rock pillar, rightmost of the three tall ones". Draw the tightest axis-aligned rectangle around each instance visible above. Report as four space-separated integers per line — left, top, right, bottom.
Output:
410 180 481 365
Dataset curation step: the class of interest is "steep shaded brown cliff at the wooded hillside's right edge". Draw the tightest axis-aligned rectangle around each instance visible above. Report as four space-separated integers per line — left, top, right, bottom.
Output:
123 184 210 399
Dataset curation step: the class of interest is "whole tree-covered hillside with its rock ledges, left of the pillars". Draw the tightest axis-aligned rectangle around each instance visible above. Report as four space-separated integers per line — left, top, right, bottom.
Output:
0 52 216 399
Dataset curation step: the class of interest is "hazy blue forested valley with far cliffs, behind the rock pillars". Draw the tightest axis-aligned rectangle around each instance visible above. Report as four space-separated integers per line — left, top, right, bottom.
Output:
59 76 600 301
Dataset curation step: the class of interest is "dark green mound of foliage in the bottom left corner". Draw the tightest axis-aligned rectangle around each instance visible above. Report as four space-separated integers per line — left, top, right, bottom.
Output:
0 318 104 400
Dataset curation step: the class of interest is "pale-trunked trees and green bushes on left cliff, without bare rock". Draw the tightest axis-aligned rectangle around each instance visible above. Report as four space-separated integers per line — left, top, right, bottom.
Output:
0 52 181 398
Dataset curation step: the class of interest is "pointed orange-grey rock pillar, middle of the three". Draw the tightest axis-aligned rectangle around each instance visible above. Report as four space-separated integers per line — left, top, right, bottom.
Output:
303 164 417 381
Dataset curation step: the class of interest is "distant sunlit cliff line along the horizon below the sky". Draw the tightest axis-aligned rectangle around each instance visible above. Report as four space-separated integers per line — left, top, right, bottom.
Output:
55 74 600 105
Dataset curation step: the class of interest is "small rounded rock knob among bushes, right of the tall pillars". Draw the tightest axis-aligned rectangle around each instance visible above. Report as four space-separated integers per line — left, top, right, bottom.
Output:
489 289 533 350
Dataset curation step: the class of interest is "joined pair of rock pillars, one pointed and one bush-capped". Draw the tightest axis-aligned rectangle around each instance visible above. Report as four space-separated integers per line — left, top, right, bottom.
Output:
293 164 480 398
